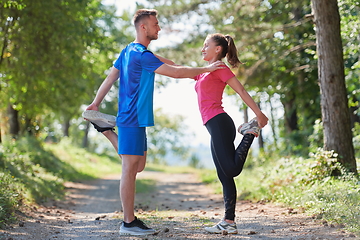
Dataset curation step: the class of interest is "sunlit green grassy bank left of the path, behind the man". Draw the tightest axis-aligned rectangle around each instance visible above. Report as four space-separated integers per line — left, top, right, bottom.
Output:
0 137 122 225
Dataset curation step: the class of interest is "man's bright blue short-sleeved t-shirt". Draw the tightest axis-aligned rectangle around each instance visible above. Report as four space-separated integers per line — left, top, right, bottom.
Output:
114 43 164 127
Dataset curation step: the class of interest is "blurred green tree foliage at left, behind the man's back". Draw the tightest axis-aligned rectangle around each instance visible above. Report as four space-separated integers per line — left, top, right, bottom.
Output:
0 0 128 137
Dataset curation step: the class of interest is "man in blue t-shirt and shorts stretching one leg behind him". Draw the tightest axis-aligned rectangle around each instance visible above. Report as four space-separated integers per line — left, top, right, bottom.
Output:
83 9 222 235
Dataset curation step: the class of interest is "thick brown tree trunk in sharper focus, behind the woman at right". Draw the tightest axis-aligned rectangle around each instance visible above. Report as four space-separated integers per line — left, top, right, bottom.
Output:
311 0 357 173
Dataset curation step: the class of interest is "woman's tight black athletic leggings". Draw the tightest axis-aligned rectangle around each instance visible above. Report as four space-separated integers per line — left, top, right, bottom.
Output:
205 113 255 220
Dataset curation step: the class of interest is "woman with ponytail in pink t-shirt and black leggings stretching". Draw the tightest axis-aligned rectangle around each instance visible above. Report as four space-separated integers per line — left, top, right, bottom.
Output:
195 33 268 234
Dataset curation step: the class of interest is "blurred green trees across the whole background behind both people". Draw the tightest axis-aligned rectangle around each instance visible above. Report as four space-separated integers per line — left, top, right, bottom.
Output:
0 0 360 171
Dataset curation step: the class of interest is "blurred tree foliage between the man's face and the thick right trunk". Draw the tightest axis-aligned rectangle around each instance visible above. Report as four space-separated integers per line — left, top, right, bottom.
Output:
146 0 321 156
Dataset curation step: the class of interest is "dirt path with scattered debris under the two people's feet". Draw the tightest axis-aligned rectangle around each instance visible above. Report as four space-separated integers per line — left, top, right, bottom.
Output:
0 172 359 240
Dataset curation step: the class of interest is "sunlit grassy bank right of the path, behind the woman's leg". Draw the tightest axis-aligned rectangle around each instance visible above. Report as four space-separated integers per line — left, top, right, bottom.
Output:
201 149 360 233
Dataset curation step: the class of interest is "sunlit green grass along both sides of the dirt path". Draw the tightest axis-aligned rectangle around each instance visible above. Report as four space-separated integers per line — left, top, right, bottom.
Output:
0 138 360 233
